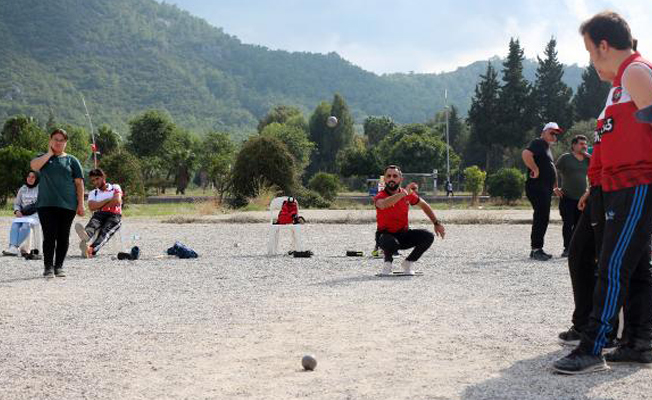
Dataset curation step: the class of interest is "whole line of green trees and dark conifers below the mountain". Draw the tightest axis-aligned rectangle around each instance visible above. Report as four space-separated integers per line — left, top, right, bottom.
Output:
0 38 609 206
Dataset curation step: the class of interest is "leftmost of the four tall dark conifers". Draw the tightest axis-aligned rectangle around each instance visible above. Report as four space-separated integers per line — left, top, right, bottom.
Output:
464 63 500 169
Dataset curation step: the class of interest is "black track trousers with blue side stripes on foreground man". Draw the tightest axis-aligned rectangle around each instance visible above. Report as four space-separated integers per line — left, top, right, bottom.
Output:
580 185 652 354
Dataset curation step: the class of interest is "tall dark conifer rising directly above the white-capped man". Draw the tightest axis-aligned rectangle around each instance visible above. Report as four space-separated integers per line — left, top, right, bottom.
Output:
533 38 573 130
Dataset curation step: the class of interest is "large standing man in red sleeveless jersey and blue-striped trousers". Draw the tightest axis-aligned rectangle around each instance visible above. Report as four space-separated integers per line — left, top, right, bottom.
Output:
553 12 652 374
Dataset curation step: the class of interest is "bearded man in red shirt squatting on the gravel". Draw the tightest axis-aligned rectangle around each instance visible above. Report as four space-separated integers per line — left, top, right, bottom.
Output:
374 165 446 276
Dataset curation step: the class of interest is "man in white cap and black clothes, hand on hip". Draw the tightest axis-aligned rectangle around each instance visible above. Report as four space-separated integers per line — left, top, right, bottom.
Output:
521 122 563 261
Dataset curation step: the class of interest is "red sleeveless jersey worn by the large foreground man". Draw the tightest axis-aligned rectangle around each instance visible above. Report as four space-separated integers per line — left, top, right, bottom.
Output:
596 53 652 192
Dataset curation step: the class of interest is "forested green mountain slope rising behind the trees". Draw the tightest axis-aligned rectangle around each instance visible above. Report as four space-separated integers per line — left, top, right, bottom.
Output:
0 0 582 137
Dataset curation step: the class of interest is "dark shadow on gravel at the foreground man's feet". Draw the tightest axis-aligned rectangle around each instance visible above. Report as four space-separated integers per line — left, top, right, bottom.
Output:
461 350 638 400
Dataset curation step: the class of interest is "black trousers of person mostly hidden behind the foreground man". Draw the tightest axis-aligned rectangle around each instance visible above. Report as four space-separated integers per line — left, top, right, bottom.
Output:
568 186 618 334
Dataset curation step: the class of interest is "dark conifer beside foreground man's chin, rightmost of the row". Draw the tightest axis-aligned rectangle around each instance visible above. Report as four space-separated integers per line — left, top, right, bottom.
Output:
573 64 611 121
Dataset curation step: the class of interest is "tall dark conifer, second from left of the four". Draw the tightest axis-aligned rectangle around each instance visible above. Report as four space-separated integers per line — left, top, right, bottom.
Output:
496 38 535 153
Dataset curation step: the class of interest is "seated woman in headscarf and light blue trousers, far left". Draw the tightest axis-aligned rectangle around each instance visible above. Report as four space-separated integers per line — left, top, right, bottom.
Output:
2 171 38 256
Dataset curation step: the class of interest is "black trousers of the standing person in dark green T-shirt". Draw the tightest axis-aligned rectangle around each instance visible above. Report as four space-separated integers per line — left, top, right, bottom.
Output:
38 207 75 269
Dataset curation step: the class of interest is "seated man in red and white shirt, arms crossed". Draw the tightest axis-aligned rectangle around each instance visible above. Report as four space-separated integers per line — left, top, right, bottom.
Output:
75 168 122 258
